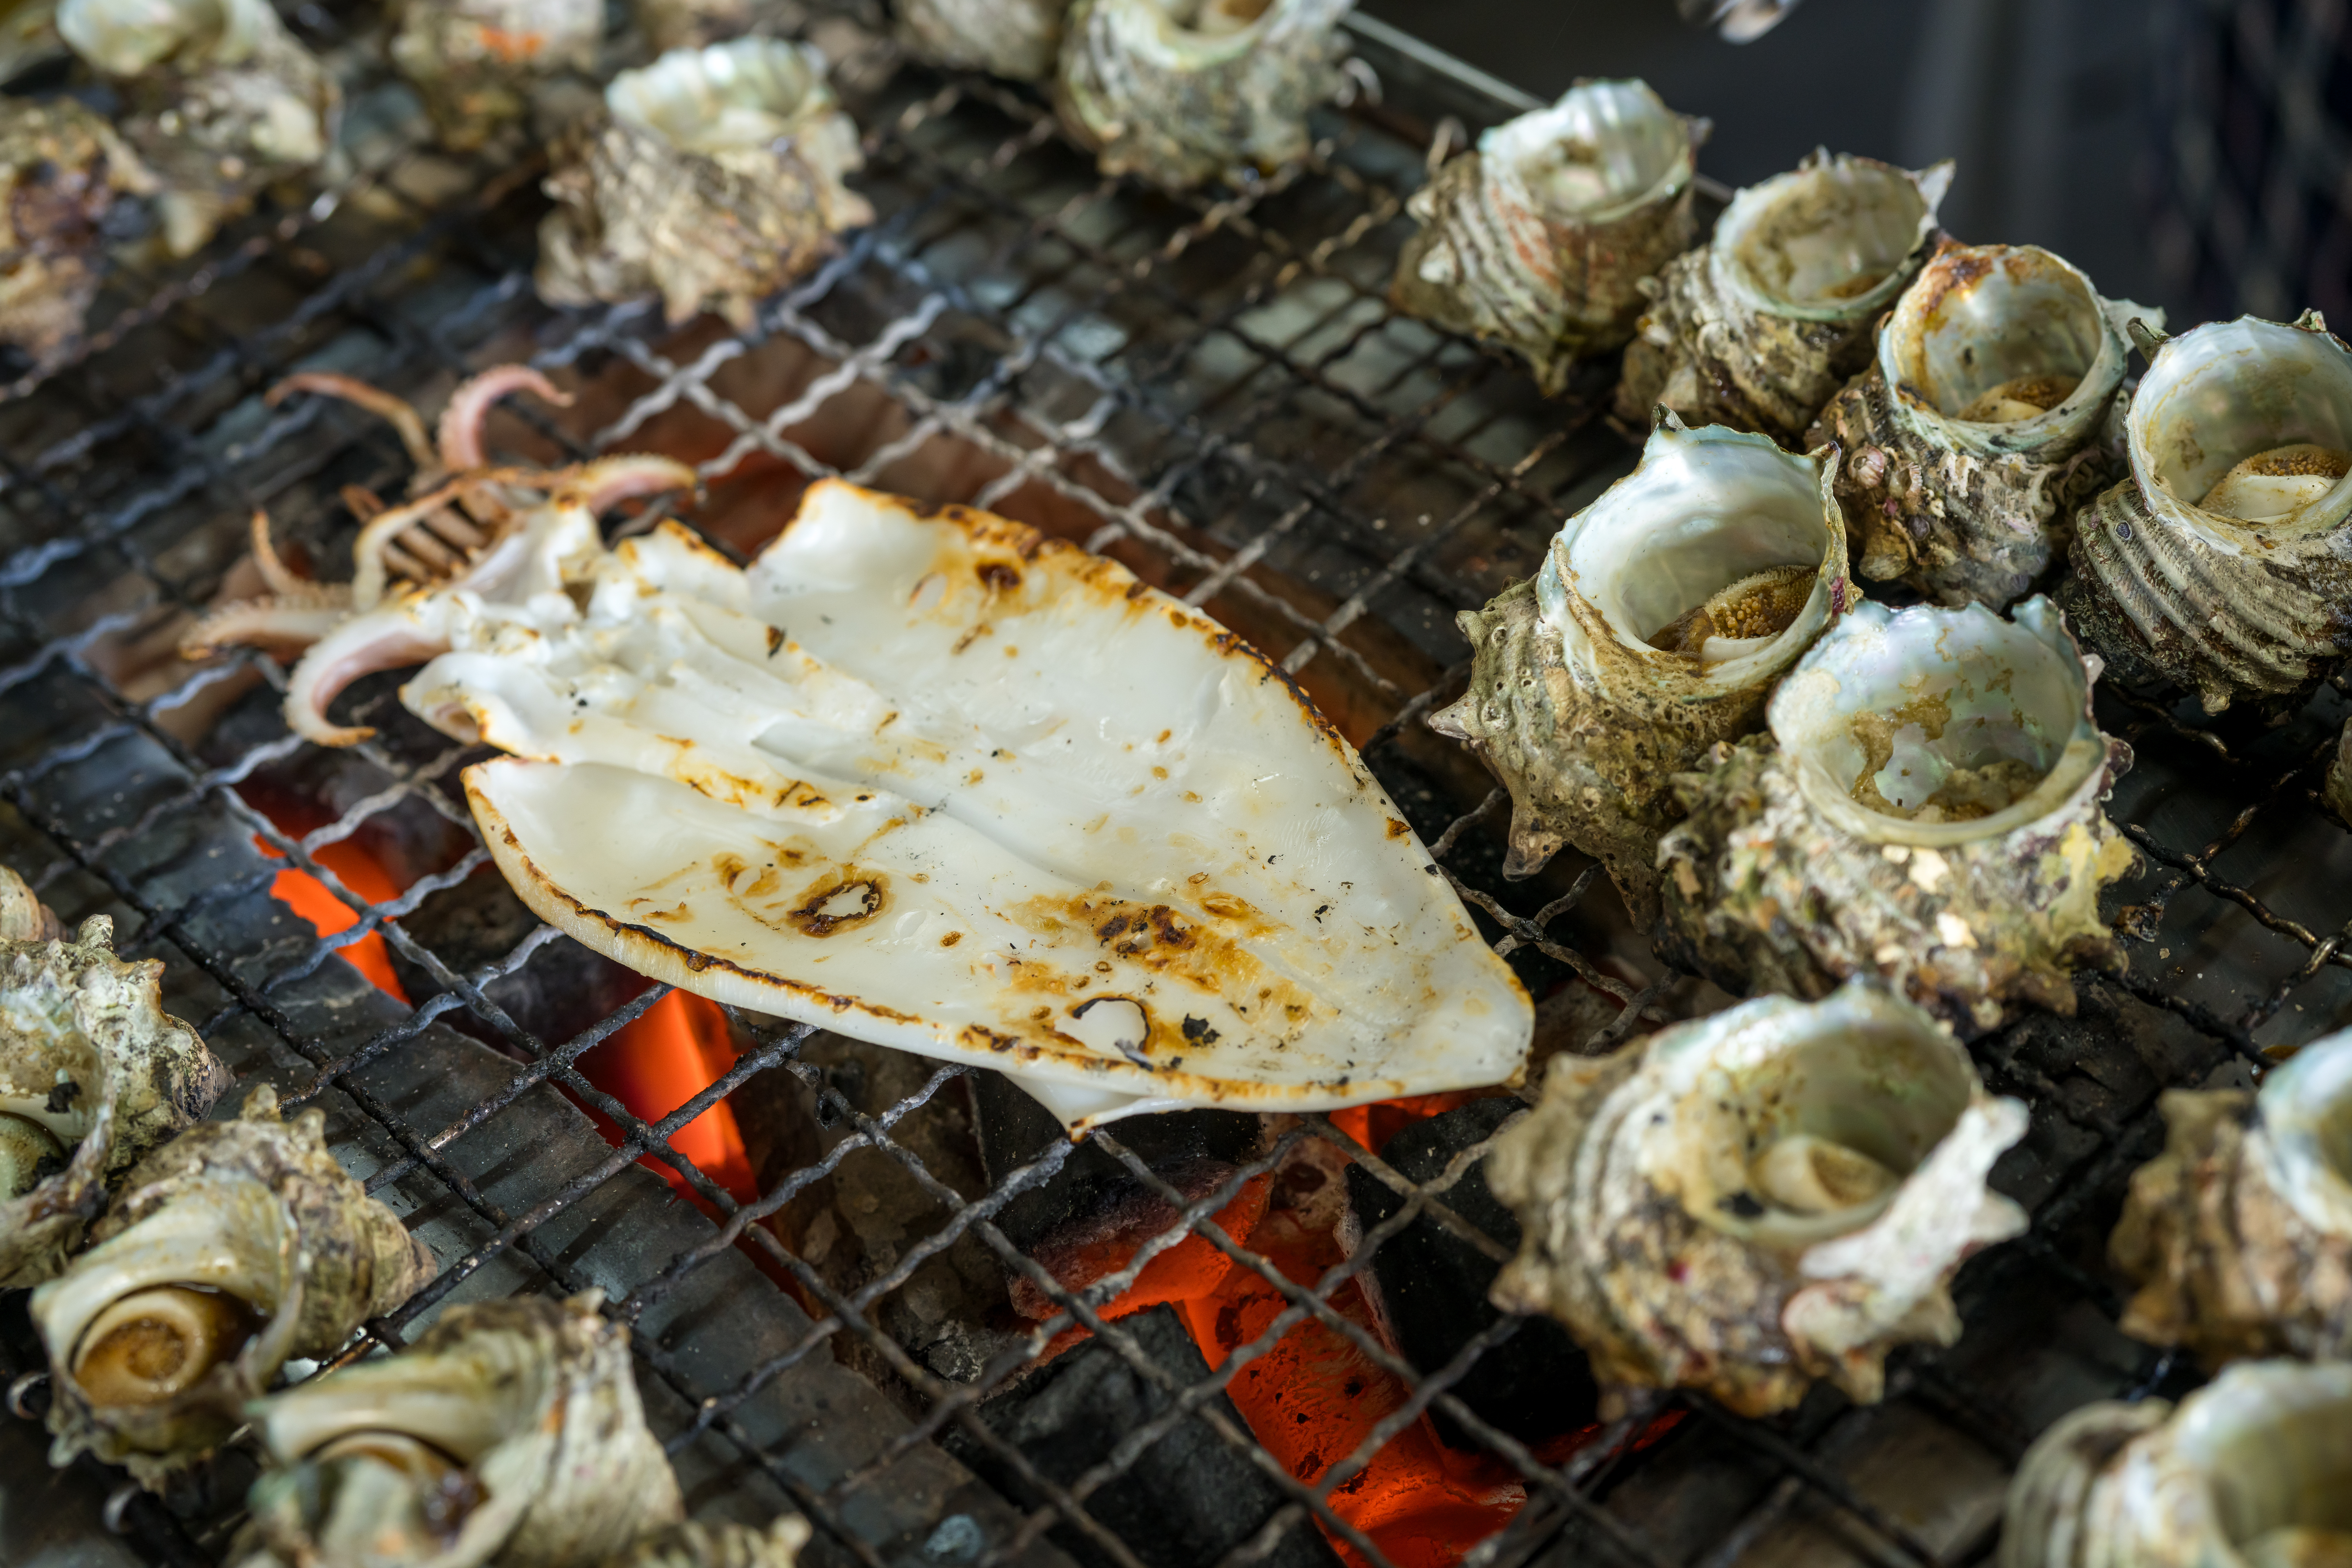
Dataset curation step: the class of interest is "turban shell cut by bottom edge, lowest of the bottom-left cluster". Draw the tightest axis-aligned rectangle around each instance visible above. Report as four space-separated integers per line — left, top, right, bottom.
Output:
238 1291 687 1568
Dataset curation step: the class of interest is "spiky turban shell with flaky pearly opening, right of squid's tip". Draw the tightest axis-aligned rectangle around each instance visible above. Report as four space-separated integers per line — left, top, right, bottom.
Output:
1658 597 2138 1032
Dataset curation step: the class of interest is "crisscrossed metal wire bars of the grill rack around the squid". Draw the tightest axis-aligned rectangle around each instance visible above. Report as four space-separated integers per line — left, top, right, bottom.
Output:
0 28 2352 1568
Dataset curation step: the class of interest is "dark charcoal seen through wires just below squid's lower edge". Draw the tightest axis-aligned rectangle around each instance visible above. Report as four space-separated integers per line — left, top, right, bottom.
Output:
969 1072 1265 1319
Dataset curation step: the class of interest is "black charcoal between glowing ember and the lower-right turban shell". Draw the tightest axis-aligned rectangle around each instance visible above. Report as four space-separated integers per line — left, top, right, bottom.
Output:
1348 1098 1599 1448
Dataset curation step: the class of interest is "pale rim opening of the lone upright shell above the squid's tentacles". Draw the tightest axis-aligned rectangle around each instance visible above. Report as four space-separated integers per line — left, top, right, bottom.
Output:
605 38 832 153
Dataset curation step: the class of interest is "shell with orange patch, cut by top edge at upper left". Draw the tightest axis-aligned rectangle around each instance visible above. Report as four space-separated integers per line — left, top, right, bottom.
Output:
391 0 605 150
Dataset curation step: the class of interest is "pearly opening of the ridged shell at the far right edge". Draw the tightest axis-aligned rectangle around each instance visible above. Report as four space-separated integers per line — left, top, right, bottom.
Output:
2126 317 2352 524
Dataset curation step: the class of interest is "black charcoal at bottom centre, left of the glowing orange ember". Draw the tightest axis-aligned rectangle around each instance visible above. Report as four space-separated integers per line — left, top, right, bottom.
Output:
941 1307 1336 1568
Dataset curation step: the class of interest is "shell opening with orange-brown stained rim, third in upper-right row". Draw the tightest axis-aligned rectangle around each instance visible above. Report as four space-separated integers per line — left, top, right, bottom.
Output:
1879 244 2108 425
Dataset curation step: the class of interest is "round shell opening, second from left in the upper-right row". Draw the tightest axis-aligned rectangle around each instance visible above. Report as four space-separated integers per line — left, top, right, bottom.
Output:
1717 157 1933 308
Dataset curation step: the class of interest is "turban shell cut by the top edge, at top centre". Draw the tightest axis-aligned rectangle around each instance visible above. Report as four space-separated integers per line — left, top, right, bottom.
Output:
1054 0 1353 190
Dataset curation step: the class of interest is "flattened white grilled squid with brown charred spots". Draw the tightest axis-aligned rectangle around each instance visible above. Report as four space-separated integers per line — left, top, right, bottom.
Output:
239 480 1533 1124
